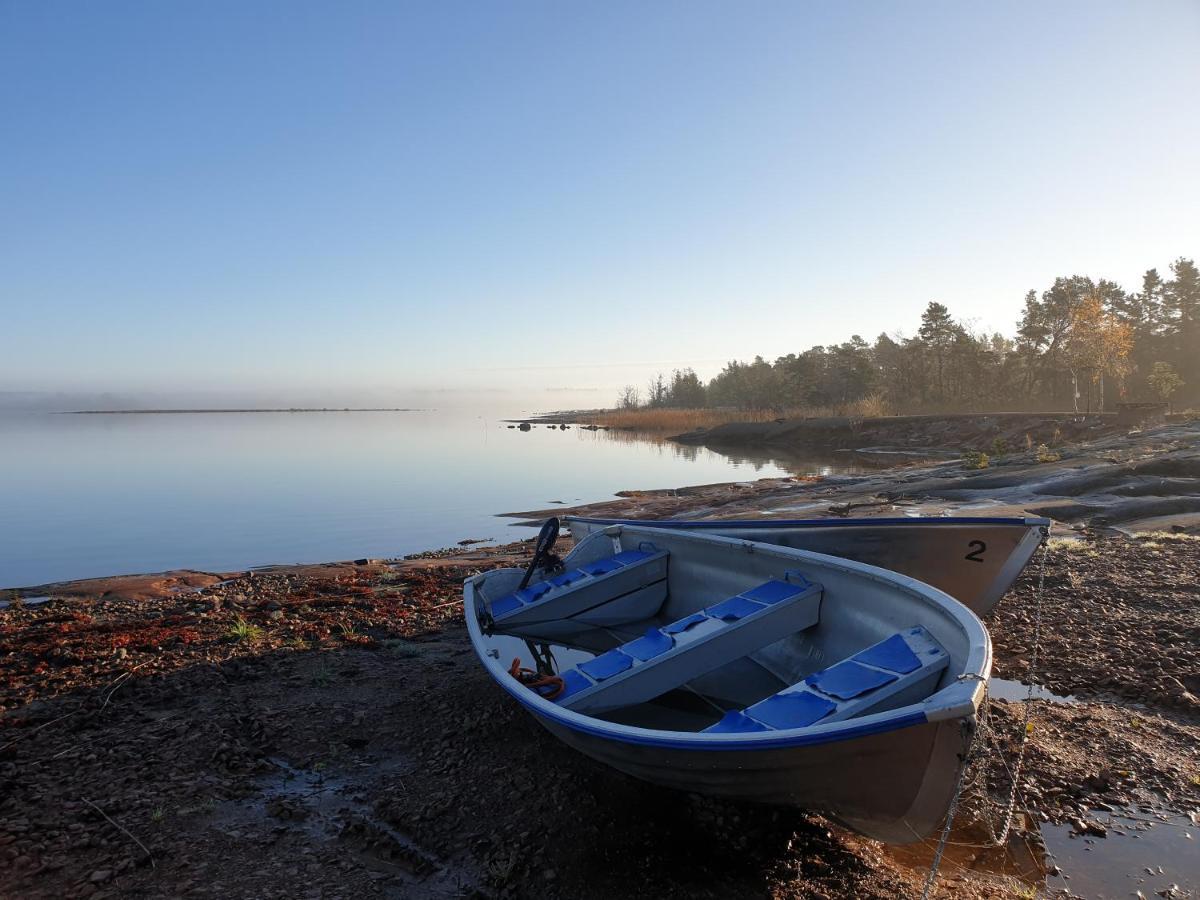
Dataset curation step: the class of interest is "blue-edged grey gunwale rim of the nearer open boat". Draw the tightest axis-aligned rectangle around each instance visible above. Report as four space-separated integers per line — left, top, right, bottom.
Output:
463 523 991 752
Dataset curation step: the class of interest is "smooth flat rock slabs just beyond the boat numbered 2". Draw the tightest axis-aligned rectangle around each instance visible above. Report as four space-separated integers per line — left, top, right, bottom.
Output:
506 421 1200 533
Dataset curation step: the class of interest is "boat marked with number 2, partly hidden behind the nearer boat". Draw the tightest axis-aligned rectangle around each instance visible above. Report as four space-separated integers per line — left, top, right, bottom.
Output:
565 516 1050 616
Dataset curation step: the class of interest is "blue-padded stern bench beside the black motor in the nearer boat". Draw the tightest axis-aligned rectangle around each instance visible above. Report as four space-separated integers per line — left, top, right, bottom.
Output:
490 544 670 635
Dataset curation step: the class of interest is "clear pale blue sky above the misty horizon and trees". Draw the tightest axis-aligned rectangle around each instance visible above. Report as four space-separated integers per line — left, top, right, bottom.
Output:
0 0 1200 408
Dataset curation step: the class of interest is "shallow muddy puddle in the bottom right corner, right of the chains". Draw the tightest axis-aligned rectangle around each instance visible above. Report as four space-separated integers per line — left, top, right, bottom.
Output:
1042 809 1200 900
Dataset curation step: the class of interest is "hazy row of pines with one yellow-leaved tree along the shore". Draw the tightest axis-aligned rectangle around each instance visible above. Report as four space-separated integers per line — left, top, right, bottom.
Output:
618 258 1200 413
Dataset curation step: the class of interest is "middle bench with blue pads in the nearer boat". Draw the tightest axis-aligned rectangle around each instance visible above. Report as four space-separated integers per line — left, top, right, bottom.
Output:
554 572 822 715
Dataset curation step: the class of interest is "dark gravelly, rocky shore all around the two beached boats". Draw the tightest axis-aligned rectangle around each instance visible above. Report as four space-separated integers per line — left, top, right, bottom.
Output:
0 426 1200 898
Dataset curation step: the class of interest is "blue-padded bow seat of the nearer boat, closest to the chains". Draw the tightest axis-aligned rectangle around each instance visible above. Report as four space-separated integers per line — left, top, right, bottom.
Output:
704 625 950 733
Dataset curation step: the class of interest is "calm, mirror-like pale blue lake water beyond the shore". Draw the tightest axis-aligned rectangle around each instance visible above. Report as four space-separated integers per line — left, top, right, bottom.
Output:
0 412 883 587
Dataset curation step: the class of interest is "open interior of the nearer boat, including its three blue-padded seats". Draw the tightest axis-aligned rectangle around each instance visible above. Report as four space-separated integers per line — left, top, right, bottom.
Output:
473 526 967 733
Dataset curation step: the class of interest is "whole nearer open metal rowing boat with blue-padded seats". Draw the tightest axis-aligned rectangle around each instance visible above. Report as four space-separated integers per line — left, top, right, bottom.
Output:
464 524 991 842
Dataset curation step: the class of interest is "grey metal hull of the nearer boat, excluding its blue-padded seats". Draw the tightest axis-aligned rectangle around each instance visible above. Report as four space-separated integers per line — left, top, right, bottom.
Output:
463 526 991 844
